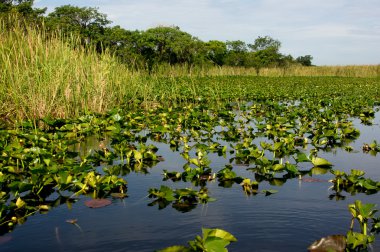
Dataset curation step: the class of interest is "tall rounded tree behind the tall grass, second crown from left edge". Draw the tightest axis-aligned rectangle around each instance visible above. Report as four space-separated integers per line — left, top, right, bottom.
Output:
47 5 111 51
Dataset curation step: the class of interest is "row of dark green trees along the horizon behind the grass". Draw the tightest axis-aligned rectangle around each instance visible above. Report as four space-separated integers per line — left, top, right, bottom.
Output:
0 0 313 74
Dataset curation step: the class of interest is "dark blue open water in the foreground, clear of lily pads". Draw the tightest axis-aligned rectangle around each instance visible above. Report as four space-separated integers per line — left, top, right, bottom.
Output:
0 115 380 252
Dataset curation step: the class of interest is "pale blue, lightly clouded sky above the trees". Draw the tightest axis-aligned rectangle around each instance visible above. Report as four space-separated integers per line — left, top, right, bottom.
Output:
34 0 380 65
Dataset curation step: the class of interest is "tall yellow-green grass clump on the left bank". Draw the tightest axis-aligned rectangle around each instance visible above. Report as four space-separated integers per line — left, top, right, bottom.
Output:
0 17 145 123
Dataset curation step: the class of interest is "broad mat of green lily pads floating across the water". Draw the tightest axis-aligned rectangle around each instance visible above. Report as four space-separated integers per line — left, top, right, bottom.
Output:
0 71 380 251
